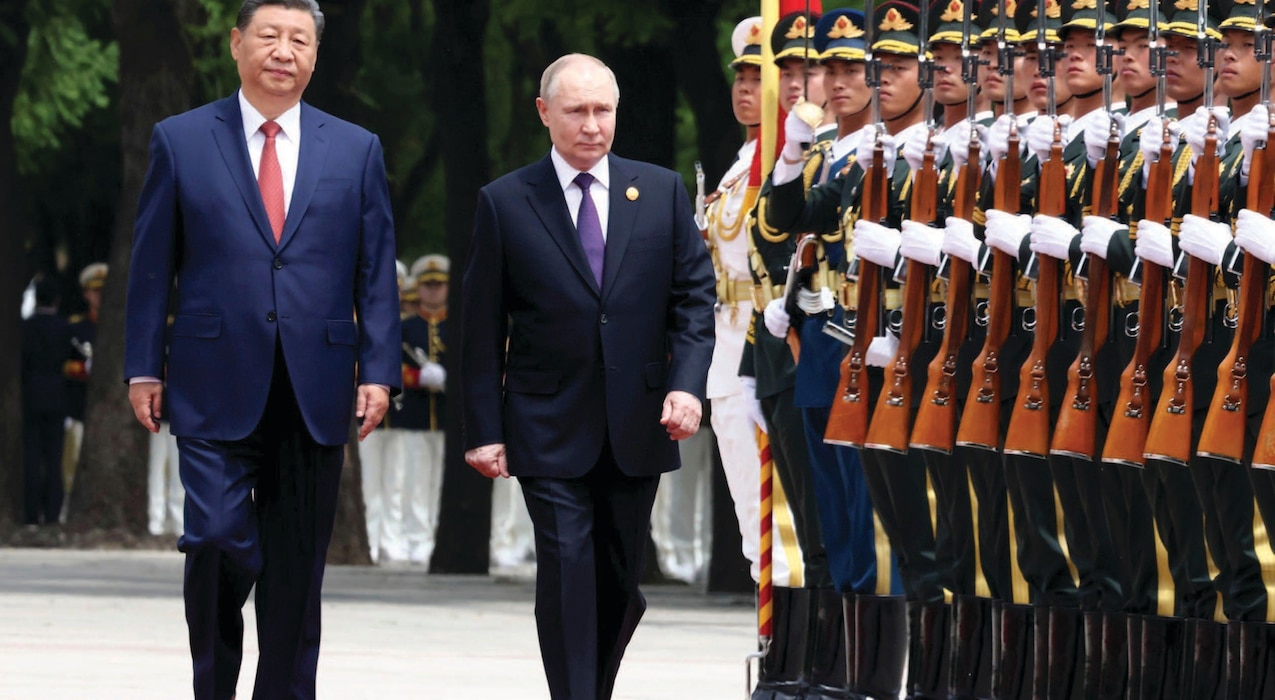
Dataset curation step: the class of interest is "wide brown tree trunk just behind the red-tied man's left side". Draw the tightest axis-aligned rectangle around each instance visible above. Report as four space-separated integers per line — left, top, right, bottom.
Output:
70 0 195 534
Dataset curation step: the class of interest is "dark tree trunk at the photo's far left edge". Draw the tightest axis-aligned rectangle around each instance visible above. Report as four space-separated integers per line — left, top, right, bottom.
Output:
0 3 31 530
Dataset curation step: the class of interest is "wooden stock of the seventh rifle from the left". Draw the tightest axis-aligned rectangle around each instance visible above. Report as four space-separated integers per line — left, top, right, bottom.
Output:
1103 128 1173 467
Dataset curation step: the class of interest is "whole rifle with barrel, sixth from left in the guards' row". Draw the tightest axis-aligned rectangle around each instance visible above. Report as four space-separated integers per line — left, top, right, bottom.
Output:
1049 0 1119 460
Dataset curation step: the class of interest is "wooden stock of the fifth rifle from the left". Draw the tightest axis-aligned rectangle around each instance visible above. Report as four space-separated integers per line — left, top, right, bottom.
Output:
1005 131 1067 458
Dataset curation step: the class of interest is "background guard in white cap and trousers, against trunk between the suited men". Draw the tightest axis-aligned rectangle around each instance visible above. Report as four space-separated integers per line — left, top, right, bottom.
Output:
400 254 451 565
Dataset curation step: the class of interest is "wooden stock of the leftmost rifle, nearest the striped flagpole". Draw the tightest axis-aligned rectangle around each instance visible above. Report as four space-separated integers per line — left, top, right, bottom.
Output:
824 140 890 448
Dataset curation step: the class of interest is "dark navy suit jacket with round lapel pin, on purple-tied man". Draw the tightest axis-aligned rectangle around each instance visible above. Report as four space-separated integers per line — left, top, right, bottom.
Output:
460 154 714 478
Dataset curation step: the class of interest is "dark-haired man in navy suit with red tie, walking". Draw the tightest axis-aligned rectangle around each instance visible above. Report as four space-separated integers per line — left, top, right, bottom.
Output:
125 0 400 700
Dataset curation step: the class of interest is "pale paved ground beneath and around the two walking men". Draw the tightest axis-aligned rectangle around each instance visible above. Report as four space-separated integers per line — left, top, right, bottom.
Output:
0 550 756 700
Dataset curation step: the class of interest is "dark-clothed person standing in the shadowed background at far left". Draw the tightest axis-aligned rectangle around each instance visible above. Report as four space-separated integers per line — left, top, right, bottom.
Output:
22 278 71 525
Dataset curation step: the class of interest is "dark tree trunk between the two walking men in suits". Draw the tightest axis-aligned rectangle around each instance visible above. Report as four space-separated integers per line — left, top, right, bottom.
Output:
425 0 491 574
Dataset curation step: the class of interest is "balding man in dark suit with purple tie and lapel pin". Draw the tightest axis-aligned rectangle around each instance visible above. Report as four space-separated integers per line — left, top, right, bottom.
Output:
460 55 713 700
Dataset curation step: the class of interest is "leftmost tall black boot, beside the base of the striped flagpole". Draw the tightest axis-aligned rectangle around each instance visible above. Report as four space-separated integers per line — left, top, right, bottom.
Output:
752 587 811 700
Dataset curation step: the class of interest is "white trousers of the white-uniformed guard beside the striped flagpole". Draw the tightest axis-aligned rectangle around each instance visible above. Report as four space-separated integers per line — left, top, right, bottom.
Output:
709 394 801 587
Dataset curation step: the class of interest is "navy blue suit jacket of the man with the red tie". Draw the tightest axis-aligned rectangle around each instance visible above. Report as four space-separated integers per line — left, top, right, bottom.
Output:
125 96 402 445
